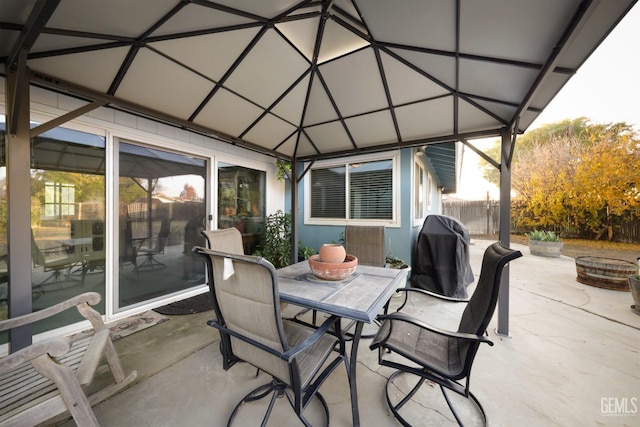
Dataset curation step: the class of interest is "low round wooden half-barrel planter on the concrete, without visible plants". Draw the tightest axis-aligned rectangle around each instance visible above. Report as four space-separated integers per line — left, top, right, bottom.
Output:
576 256 638 292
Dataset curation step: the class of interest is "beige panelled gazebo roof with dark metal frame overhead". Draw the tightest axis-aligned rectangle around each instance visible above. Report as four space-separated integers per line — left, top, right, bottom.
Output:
0 0 635 190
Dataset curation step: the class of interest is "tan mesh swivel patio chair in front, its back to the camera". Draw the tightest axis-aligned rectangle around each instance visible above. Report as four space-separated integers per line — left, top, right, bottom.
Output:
194 247 349 426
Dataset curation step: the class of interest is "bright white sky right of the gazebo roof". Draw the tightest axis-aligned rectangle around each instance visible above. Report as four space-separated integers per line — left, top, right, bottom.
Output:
451 4 640 200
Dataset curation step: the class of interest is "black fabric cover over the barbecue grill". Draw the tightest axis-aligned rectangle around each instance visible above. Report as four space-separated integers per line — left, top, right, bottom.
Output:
411 215 473 298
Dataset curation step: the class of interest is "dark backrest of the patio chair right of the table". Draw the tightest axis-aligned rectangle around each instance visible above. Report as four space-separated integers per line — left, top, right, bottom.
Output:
458 242 522 335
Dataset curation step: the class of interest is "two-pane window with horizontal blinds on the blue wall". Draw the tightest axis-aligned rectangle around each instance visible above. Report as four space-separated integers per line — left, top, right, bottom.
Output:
306 155 397 224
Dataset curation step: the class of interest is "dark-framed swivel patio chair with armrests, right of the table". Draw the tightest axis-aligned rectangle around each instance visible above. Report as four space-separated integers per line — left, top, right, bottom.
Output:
370 242 522 426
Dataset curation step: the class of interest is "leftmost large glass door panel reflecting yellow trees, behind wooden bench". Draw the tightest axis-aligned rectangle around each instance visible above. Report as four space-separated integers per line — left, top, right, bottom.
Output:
30 127 106 333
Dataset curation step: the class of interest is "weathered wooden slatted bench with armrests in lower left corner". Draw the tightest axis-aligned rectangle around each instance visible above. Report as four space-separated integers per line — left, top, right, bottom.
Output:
0 292 137 427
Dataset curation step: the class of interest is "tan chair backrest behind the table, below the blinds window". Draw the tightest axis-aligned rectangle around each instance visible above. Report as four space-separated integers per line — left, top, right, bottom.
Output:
344 225 385 267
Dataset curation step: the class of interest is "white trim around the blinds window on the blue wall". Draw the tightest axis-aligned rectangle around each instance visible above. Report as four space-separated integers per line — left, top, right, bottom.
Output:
304 150 400 227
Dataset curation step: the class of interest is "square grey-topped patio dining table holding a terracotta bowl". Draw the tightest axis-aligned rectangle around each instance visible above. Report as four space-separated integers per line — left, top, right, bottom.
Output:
278 261 408 426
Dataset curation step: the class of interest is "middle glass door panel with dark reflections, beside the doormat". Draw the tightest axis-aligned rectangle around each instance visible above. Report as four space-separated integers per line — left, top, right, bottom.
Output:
116 141 207 311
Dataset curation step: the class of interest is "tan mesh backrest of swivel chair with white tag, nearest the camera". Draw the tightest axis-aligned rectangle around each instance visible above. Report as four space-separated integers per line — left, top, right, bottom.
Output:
196 248 291 383
